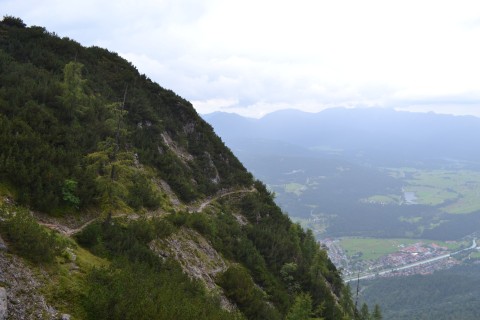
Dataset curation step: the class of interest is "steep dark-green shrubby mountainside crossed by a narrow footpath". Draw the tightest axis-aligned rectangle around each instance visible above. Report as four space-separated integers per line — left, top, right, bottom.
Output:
0 16 355 320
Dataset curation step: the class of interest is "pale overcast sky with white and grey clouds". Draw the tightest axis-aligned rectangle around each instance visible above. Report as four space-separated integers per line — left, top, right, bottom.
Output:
0 0 480 117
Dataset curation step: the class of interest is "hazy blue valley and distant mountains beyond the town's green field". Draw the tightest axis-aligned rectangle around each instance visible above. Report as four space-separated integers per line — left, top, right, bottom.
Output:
204 109 480 240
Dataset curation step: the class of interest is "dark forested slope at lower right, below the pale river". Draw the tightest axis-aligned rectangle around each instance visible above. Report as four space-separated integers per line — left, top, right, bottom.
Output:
361 263 480 320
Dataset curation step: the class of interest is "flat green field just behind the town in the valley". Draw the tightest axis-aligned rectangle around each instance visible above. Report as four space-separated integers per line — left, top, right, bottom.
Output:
340 238 468 260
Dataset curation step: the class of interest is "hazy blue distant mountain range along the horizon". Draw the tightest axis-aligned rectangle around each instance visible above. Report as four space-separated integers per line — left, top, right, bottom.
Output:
204 108 480 166
